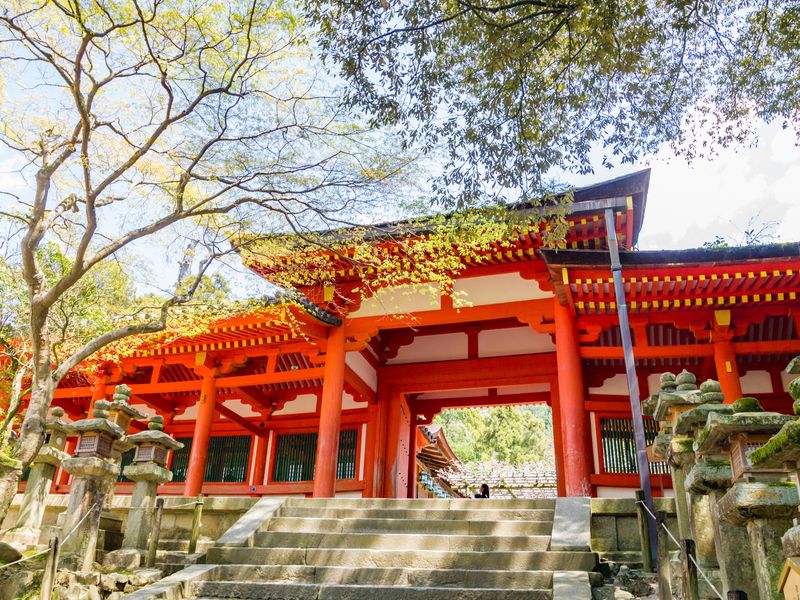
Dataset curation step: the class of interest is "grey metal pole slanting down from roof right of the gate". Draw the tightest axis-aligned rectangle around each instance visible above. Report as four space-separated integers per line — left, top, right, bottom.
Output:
605 208 656 557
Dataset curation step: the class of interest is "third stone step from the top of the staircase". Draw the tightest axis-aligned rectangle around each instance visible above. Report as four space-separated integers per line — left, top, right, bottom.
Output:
266 511 553 546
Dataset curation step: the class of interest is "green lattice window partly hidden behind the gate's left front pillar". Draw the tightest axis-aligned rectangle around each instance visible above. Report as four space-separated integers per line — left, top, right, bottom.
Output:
272 429 358 482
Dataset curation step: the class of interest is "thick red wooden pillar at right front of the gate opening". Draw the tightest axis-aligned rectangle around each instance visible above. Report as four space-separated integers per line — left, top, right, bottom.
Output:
554 298 592 496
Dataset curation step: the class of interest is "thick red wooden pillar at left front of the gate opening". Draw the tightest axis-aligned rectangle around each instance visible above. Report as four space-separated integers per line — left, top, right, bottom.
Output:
313 327 345 498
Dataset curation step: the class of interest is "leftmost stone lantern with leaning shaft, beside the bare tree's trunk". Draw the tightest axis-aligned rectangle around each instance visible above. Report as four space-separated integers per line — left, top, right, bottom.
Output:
7 406 73 546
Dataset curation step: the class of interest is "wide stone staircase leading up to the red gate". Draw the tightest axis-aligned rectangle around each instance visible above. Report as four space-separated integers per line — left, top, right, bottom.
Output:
175 498 599 600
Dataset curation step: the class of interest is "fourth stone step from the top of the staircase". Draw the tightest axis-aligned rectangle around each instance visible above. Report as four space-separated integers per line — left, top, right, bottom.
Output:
253 530 550 552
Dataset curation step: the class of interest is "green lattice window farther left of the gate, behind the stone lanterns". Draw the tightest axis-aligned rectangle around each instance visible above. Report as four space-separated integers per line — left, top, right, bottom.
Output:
172 435 252 483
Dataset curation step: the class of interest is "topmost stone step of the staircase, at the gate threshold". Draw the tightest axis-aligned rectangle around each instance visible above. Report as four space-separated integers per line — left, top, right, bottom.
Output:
283 498 556 510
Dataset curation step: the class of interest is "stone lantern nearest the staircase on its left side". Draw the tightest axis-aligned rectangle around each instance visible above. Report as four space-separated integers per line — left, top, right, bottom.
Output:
105 415 183 569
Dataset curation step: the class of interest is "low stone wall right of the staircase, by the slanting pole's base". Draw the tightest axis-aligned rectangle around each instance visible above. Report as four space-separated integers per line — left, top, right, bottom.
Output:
591 498 678 565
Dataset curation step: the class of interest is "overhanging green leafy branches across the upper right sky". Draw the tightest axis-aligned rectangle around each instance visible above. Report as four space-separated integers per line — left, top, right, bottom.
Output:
306 0 800 206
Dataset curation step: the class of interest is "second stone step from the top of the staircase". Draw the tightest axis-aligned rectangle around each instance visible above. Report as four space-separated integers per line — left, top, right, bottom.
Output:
275 506 553 523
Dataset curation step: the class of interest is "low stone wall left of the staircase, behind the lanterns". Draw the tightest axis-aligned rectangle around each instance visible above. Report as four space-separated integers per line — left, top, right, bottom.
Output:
2 494 257 545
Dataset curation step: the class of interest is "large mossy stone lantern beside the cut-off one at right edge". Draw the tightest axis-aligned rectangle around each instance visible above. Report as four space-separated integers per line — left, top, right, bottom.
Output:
695 398 798 600
